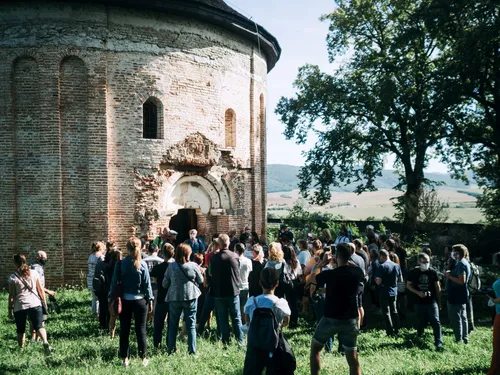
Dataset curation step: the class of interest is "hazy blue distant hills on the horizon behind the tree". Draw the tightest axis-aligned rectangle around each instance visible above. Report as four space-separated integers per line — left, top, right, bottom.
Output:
267 164 474 193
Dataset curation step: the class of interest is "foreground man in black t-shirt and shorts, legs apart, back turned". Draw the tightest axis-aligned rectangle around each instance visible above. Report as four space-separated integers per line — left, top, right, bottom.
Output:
310 243 364 375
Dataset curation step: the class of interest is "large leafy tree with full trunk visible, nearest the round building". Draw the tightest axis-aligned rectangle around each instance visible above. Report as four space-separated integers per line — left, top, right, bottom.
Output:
276 0 457 238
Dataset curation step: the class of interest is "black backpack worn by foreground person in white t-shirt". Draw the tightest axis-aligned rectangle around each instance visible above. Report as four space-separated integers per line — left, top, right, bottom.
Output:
248 297 280 353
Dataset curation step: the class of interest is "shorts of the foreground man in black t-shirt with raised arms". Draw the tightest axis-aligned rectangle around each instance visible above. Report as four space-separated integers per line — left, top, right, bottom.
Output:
313 317 359 351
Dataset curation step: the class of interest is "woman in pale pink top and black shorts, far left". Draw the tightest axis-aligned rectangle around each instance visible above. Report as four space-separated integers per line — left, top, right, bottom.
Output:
8 254 52 354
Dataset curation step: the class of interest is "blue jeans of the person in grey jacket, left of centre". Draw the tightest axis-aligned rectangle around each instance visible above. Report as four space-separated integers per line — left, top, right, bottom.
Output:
167 298 198 354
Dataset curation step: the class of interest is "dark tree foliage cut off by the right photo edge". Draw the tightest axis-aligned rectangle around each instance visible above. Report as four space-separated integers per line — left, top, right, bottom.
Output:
425 0 500 224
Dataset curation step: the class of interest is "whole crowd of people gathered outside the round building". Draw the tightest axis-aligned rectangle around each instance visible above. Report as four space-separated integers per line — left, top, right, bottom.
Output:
9 224 500 375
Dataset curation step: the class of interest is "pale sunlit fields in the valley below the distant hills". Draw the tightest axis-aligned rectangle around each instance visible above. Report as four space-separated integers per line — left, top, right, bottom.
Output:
267 188 484 224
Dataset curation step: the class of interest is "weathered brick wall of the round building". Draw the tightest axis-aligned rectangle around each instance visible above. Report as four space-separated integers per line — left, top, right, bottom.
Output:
0 2 267 285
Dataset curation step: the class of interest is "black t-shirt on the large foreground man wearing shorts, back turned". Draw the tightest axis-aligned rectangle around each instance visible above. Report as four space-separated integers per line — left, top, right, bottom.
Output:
316 266 364 320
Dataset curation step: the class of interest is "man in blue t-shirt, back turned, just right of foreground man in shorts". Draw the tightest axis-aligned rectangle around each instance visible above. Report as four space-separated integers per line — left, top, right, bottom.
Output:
375 249 403 336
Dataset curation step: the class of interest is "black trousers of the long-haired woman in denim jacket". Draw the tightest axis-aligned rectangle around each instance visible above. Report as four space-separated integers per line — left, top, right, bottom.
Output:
120 298 148 358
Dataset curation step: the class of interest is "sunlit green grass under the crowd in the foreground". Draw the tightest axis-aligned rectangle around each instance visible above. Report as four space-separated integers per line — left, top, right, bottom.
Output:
0 291 492 375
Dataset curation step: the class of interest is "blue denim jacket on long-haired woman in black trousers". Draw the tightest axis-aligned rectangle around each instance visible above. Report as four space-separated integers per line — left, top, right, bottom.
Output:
109 256 154 301
